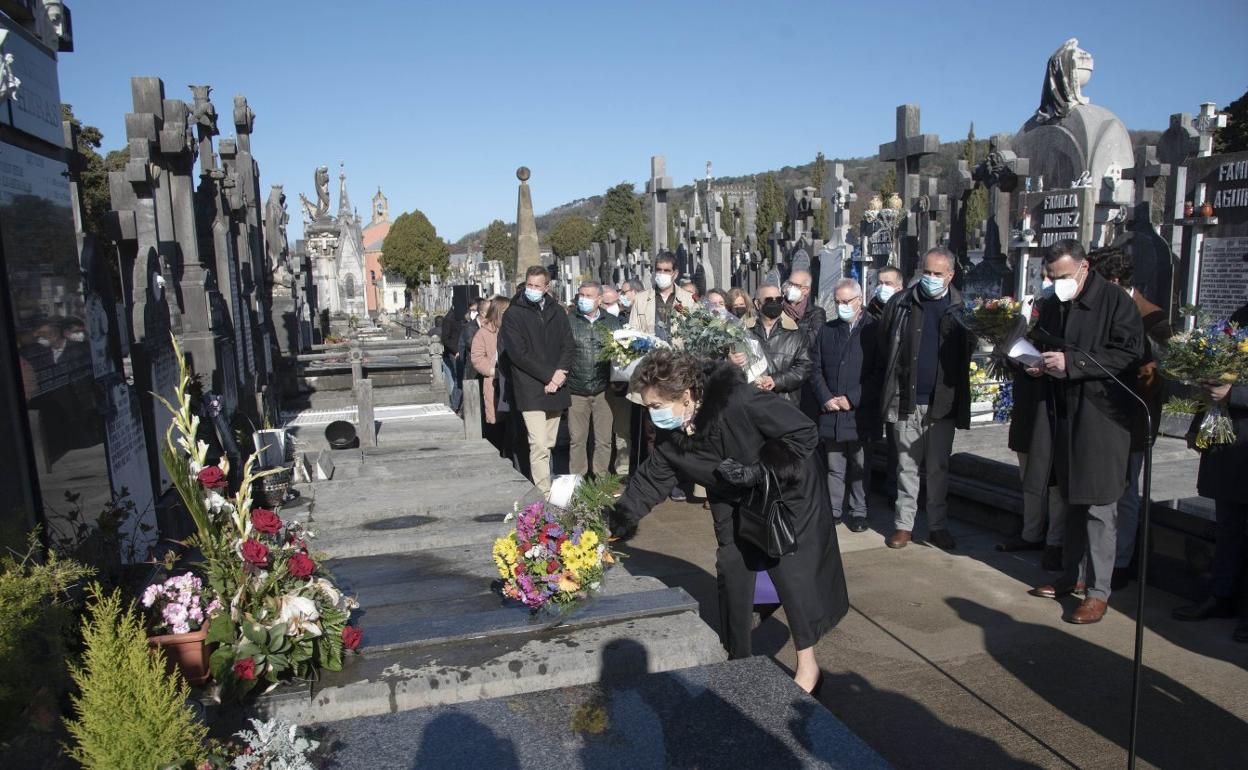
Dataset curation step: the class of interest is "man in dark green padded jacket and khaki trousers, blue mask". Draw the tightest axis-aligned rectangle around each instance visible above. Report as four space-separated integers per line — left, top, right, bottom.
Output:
568 281 622 478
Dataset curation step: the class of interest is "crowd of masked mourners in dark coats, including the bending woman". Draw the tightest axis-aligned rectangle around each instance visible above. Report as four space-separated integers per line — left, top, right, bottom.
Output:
442 241 1248 690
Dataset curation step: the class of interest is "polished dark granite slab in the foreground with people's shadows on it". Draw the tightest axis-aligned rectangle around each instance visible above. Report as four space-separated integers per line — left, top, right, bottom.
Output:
300 644 890 770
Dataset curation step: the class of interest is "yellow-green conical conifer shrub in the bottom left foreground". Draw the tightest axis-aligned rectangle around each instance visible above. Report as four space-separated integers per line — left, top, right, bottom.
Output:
66 585 207 770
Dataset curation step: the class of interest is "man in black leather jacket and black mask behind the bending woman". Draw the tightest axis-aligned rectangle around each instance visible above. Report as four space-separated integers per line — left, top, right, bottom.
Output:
729 285 811 406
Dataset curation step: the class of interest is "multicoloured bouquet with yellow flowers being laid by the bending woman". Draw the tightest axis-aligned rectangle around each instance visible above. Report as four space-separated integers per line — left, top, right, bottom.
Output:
492 477 619 613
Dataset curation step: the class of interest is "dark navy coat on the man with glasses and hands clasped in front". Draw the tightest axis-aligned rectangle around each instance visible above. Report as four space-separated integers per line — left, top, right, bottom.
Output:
810 313 882 442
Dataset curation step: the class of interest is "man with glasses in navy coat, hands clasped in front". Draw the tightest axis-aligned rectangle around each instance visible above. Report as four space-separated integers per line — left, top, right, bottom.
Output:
811 278 880 532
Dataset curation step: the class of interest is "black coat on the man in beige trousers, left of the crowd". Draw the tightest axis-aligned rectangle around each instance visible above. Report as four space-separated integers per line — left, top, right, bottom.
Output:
499 292 577 412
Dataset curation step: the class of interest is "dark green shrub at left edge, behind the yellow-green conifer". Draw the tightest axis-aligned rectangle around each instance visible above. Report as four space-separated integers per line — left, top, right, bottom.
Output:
0 533 92 738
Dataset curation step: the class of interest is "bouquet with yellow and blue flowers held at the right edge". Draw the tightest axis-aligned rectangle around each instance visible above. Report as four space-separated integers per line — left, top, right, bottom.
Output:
1161 319 1248 449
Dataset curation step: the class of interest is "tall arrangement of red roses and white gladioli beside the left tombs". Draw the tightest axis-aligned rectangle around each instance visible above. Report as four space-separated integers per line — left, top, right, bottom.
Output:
154 339 363 698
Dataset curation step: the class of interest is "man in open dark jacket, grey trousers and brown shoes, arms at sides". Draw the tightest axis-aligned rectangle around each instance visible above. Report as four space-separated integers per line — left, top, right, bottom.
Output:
879 247 973 549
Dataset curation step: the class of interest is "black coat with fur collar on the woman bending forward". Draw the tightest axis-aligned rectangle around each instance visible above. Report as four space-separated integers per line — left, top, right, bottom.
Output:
617 364 849 644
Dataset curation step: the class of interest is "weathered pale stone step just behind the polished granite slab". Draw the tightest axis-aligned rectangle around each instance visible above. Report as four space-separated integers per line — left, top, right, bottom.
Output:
251 612 725 725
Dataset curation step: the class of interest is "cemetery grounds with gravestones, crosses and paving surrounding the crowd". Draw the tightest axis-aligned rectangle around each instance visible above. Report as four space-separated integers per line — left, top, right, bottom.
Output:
0 0 1248 768
